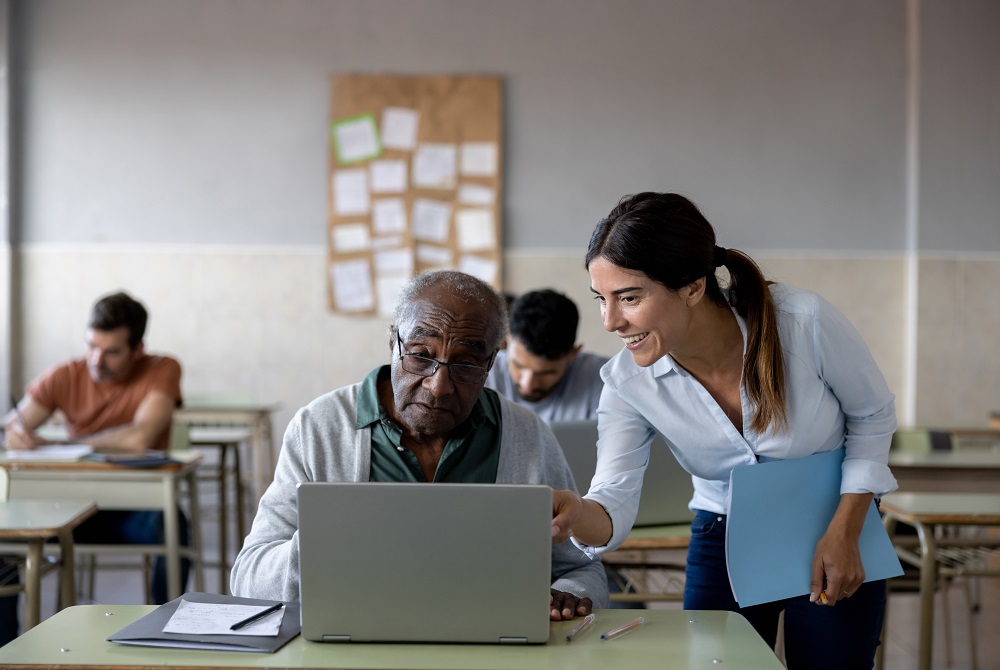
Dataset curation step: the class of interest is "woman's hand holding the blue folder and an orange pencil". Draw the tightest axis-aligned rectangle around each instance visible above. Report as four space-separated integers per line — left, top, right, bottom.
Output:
809 493 872 606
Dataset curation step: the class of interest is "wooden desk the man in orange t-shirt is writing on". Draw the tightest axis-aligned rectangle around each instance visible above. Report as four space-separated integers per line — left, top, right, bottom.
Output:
0 452 205 599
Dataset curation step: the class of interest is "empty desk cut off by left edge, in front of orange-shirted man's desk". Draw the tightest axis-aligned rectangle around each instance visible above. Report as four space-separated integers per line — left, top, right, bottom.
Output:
0 500 97 630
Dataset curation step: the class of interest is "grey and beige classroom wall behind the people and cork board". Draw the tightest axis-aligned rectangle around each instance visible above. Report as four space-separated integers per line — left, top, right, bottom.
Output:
0 0 1000 427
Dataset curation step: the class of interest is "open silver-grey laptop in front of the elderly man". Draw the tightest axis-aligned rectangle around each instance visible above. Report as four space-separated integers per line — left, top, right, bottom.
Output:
298 482 552 644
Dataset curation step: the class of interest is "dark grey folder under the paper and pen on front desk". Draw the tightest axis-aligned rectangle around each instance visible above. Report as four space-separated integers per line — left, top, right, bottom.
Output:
107 593 302 653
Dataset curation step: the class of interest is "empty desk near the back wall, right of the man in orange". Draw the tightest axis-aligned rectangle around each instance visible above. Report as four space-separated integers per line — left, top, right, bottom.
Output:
174 400 279 505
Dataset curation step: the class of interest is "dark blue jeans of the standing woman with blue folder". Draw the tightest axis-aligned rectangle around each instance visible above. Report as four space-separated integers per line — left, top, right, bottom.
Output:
684 510 886 670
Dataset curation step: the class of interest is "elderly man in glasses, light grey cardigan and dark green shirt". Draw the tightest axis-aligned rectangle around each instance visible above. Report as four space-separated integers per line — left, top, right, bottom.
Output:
231 271 607 620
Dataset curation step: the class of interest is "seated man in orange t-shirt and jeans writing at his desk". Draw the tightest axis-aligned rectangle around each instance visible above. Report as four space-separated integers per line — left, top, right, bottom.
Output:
0 293 188 643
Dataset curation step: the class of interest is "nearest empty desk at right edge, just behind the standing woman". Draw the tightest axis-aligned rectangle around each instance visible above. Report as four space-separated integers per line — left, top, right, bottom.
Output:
881 493 1000 670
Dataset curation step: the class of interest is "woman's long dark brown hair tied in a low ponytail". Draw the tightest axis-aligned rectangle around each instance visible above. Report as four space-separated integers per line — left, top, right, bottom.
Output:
584 192 788 432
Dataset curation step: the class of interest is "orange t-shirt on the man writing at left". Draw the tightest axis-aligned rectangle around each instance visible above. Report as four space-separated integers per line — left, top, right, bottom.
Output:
28 354 181 451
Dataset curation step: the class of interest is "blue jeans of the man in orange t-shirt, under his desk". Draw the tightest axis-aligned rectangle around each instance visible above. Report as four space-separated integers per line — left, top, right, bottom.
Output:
73 510 191 605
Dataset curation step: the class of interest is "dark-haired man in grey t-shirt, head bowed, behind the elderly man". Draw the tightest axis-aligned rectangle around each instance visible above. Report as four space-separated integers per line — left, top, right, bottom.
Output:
486 289 608 426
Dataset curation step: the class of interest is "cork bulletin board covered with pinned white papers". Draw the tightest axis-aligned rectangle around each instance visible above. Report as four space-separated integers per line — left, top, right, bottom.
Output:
327 74 503 315
